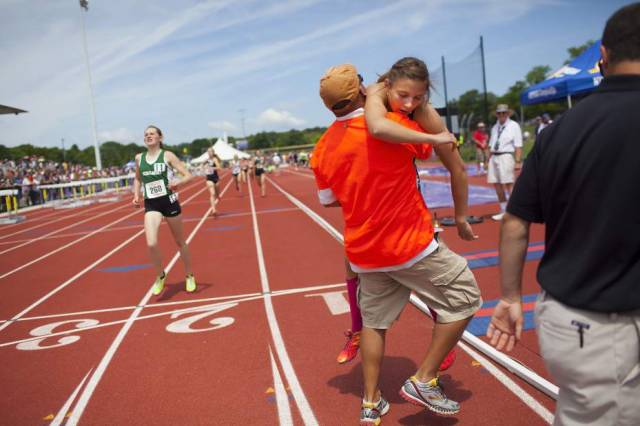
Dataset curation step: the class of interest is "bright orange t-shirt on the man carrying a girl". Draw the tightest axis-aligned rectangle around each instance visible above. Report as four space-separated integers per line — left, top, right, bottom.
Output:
311 113 433 269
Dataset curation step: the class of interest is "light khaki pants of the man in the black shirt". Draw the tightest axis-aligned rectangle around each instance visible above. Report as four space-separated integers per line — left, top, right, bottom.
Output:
535 292 640 426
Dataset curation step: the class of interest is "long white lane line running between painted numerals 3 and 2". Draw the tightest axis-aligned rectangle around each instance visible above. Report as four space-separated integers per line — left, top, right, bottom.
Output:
67 180 231 426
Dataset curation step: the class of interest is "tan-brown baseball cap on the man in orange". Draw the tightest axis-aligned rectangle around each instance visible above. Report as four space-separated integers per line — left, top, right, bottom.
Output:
320 64 362 113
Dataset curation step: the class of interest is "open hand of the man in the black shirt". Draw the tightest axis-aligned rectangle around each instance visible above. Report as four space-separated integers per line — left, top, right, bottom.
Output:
487 299 524 352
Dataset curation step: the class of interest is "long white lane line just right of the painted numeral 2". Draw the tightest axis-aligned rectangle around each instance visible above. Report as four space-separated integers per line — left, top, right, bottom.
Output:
248 184 318 426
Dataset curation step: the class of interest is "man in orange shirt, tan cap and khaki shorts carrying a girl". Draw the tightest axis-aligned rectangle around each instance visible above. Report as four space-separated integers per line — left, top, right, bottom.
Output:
311 65 482 425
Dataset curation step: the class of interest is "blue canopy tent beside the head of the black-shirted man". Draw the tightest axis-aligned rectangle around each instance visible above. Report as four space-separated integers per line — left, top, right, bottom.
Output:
520 40 602 108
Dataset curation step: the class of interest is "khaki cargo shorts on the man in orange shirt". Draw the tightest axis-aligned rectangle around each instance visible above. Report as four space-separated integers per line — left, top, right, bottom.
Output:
358 244 482 329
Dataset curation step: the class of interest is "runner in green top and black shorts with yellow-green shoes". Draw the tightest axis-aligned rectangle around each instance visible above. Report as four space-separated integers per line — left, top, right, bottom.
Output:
133 126 196 296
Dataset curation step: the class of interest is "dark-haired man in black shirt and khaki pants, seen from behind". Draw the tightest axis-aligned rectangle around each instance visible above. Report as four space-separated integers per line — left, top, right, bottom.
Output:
487 3 640 425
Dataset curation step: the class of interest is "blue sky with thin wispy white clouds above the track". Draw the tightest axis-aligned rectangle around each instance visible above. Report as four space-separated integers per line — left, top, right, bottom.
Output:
0 0 631 147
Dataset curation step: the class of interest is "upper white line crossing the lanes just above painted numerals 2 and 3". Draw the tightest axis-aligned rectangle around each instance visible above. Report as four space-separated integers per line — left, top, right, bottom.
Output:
0 283 345 324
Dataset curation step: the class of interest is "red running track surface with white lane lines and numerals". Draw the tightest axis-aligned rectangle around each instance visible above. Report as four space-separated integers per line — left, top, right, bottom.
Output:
0 169 554 425
